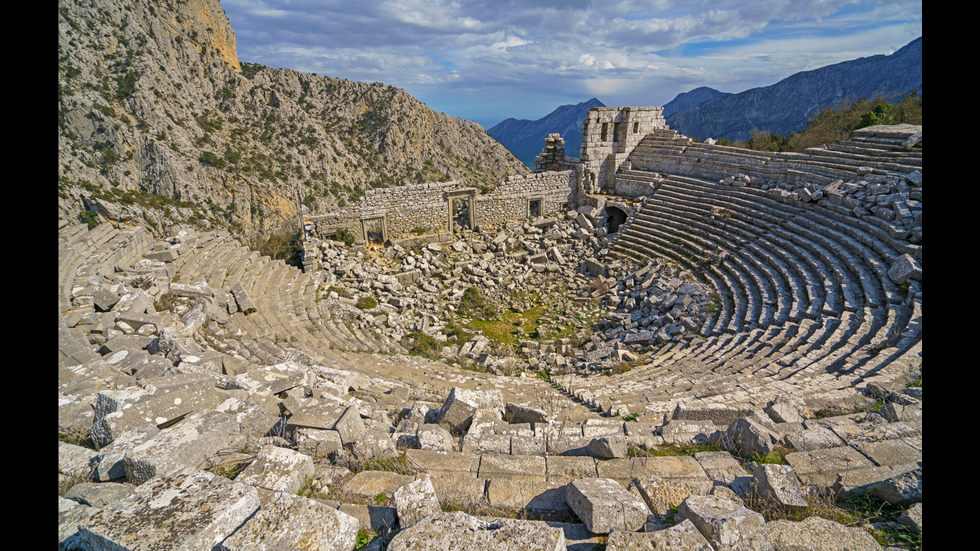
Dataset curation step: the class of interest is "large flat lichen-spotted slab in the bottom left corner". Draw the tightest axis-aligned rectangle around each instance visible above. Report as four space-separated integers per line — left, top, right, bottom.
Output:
79 467 259 551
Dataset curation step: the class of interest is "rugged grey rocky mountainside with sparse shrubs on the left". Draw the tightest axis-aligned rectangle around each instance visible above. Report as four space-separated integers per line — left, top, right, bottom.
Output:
58 0 528 236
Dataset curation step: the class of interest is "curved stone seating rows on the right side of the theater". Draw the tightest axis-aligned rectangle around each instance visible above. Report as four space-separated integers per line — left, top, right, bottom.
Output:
589 169 921 412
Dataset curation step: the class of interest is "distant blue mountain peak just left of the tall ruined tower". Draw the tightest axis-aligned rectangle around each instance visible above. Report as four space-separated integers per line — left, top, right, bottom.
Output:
487 98 605 167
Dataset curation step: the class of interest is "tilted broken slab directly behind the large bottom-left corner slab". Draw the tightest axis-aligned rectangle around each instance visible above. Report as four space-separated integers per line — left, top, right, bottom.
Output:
124 410 247 485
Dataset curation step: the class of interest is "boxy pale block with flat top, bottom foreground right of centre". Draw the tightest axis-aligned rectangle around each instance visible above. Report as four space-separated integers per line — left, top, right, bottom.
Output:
565 478 650 534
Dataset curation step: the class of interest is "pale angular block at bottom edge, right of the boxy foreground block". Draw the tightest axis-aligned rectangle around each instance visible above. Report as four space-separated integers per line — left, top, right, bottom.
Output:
675 496 768 551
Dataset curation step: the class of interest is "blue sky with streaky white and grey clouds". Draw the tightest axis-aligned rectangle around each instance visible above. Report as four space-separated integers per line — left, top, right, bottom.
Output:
221 0 922 128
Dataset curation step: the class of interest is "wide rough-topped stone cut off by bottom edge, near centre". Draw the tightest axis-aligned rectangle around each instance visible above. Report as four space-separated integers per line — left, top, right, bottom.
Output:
388 512 565 551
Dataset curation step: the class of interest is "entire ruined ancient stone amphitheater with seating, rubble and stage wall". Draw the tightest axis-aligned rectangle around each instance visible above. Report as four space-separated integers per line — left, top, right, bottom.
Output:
58 107 922 551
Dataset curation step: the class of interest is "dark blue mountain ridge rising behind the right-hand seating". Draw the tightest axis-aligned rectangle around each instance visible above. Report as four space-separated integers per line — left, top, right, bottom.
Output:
667 37 922 140
